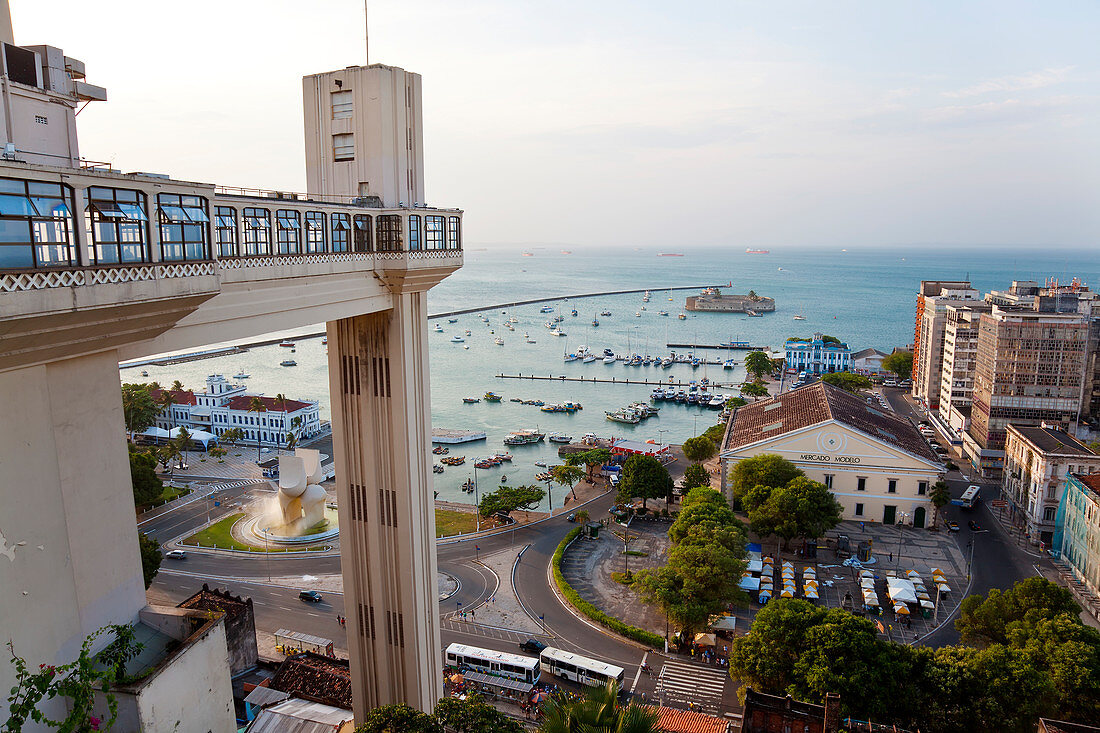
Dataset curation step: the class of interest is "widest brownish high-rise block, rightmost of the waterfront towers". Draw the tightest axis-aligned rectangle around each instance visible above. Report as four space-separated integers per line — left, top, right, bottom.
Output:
963 298 1089 475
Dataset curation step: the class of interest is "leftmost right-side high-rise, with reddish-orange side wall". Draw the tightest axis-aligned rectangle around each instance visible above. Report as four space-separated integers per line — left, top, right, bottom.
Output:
913 280 979 409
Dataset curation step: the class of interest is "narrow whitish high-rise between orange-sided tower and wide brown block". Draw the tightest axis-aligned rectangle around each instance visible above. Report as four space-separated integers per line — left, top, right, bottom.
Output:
938 303 992 433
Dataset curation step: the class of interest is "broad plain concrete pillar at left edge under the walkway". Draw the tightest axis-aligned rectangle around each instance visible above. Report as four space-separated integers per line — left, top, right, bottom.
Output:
0 351 145 716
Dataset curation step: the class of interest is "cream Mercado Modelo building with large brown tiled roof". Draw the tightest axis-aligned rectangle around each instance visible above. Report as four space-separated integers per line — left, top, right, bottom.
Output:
719 382 945 527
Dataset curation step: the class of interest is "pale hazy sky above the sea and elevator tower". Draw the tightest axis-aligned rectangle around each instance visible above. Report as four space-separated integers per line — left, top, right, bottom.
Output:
11 0 1100 251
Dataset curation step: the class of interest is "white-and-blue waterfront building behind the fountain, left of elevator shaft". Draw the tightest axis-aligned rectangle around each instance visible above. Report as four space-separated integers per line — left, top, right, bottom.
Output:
152 374 321 446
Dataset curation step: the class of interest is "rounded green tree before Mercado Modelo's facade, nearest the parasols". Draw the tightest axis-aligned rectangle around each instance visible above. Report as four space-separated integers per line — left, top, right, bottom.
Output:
741 475 843 549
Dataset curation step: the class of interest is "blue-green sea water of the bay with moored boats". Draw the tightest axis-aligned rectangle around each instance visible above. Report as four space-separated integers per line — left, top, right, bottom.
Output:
121 245 1100 508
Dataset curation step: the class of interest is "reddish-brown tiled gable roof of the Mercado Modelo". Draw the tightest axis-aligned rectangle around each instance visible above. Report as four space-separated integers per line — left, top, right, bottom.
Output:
725 382 941 463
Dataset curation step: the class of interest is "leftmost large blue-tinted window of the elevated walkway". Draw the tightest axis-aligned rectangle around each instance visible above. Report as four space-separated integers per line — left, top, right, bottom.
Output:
0 178 80 270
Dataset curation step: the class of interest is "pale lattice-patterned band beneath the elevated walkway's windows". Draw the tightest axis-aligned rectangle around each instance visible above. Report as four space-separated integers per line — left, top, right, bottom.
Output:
0 245 462 293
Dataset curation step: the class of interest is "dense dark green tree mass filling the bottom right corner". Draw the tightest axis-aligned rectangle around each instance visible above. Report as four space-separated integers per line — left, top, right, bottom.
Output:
729 578 1100 733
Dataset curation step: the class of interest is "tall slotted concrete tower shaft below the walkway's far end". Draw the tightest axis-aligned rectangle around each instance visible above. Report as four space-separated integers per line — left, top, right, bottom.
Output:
328 292 443 722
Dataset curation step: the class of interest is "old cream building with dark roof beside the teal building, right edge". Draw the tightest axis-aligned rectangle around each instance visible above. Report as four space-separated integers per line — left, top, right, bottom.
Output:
1001 425 1100 547
